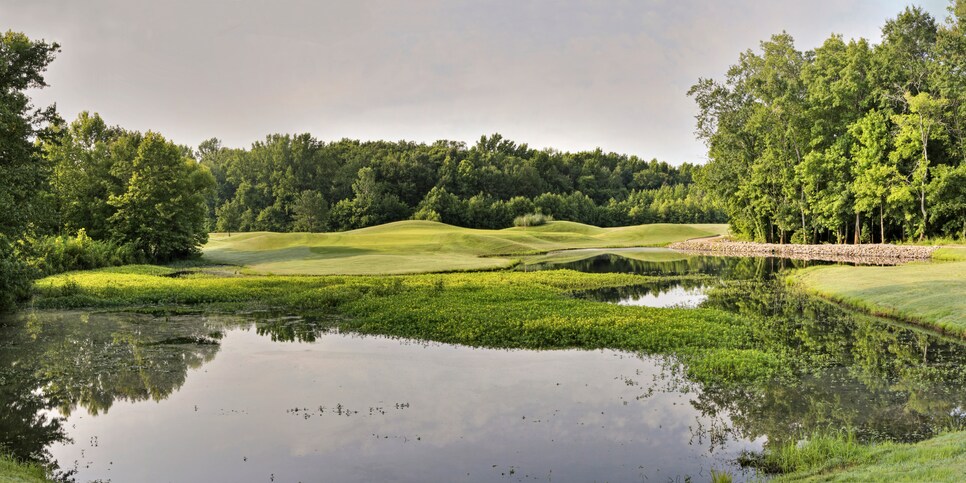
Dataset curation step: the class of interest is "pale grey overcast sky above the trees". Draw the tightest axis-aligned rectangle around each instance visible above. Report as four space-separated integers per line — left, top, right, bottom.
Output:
0 0 947 164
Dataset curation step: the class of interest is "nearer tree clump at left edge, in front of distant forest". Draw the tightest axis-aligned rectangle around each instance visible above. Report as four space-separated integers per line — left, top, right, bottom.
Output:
0 32 215 310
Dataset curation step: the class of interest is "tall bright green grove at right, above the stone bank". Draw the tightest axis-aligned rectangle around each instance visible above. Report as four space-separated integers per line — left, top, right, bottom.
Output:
689 0 966 243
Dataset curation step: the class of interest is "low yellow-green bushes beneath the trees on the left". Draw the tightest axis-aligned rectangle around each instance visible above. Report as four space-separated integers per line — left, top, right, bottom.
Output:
29 229 145 276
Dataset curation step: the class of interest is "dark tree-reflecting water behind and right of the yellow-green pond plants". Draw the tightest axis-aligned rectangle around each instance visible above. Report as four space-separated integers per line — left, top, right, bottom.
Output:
530 249 966 450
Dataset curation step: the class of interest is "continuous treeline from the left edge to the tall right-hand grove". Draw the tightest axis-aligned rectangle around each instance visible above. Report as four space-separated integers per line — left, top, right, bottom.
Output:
0 28 725 309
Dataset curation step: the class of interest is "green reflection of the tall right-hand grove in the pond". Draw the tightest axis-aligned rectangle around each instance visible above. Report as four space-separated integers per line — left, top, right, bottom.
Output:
696 281 966 450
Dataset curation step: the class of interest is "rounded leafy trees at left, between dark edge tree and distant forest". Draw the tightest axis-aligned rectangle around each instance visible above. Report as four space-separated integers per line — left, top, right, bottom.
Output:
43 112 216 261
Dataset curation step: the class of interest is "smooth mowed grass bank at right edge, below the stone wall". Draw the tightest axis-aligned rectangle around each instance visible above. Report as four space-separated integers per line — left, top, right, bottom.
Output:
790 261 966 336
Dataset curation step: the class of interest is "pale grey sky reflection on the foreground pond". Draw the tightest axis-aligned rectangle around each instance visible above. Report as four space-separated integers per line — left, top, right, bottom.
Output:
51 329 761 481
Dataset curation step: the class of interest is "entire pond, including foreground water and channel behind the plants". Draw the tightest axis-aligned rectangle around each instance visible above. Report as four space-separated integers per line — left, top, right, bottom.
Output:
0 249 966 481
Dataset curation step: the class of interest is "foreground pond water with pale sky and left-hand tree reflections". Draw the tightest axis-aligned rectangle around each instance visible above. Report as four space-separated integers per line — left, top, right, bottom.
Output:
0 313 762 482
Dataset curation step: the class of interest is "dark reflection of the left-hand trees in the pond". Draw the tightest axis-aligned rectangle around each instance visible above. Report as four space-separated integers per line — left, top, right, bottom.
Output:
0 313 332 466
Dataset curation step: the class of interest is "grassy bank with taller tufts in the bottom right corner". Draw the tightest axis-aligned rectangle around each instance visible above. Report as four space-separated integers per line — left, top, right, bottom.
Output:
759 431 966 482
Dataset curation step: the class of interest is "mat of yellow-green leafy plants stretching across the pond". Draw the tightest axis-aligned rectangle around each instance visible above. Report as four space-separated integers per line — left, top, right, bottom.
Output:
34 266 782 388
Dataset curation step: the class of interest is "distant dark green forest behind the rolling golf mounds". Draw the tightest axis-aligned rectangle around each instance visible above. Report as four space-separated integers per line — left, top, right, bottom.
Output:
198 134 725 232
